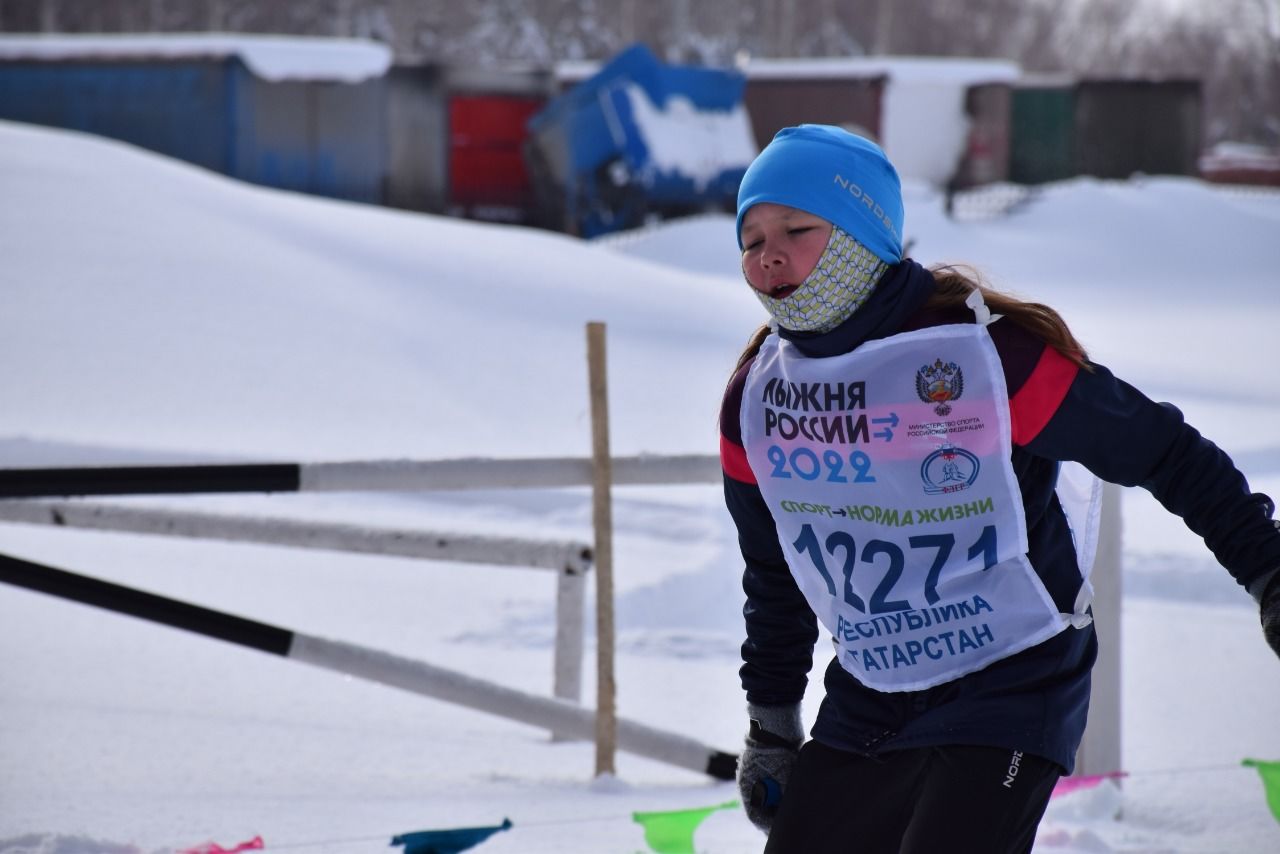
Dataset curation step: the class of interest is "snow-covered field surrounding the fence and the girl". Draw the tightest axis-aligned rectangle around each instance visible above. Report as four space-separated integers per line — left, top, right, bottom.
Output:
0 123 1280 854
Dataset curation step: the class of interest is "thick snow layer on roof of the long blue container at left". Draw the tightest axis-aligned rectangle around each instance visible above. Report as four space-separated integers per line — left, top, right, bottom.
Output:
0 33 392 83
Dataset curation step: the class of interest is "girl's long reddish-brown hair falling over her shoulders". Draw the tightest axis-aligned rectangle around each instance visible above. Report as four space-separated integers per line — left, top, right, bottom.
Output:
733 264 1089 374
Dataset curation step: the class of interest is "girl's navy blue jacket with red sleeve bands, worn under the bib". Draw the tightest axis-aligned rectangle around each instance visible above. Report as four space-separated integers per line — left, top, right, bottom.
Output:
721 260 1280 773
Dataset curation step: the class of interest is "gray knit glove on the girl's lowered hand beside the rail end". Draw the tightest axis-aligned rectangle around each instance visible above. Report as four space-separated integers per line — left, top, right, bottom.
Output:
737 703 804 834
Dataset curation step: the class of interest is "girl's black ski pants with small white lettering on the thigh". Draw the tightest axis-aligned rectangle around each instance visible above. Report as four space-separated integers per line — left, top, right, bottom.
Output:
764 741 1062 854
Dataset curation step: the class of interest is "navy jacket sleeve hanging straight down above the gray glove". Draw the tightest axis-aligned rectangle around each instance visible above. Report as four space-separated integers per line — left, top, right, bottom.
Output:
721 364 818 705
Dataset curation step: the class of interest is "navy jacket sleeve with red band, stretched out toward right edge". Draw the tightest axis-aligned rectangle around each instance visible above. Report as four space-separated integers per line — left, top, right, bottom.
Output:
1010 340 1280 592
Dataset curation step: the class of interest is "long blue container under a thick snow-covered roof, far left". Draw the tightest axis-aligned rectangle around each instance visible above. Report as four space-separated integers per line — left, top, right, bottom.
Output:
0 56 387 202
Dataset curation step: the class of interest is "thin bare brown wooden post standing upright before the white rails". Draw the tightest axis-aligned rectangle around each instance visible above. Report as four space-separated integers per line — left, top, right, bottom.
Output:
586 321 618 777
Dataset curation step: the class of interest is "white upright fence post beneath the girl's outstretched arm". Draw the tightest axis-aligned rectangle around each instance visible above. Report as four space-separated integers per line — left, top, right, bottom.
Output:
1075 484 1124 776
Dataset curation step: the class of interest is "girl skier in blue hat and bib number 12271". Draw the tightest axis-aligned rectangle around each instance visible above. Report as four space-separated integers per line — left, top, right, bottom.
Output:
721 125 1280 854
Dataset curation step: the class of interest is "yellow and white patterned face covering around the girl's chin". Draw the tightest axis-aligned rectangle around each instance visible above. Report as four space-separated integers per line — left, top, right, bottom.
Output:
751 227 888 332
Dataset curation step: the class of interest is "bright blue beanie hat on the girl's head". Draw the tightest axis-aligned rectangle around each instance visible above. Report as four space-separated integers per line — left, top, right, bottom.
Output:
737 124 902 264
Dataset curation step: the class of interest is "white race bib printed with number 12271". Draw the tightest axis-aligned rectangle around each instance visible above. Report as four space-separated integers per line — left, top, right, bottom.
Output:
742 324 1087 691
